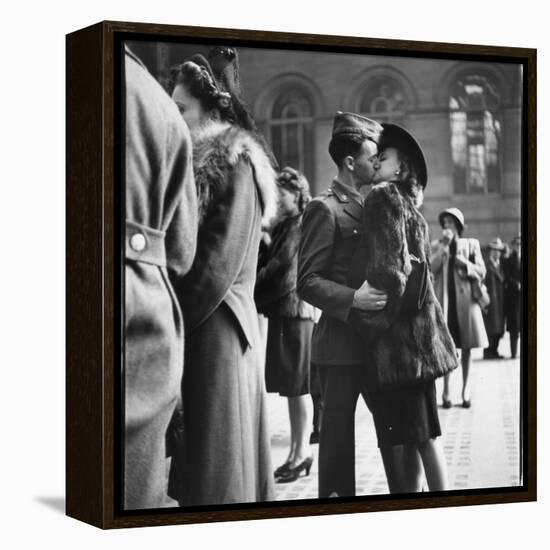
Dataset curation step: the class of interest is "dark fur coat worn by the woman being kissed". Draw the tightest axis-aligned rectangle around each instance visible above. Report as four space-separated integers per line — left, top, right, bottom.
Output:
350 182 457 387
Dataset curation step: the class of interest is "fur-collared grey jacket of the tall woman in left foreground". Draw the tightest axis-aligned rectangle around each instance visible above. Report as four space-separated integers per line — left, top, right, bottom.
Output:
172 122 277 345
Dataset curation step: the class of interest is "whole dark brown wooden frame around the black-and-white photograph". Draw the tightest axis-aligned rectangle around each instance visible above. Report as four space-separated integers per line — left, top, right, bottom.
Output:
66 21 537 528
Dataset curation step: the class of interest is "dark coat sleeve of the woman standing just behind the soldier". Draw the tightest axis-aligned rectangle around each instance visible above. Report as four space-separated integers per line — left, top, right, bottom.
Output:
254 221 300 307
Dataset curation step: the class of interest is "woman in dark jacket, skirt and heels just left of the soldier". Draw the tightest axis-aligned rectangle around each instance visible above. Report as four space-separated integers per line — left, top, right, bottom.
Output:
255 167 315 483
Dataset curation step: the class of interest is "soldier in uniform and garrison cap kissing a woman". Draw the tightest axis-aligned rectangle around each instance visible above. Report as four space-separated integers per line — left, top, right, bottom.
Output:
298 112 387 498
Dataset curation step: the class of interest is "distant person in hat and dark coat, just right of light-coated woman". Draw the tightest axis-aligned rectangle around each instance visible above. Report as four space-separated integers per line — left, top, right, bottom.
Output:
483 237 504 359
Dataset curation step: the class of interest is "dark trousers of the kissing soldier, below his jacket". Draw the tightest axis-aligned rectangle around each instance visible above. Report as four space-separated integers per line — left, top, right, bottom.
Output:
319 365 368 498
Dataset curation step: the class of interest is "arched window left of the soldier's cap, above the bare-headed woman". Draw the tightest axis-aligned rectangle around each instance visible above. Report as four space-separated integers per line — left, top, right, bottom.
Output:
266 85 314 181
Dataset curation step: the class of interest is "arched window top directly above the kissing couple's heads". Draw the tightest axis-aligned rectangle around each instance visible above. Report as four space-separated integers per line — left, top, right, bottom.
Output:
359 75 410 124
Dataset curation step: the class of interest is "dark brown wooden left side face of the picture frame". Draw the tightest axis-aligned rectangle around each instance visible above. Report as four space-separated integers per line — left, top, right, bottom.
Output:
66 25 104 526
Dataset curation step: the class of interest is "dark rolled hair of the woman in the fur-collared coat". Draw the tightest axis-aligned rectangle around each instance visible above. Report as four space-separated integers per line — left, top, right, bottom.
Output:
170 61 236 122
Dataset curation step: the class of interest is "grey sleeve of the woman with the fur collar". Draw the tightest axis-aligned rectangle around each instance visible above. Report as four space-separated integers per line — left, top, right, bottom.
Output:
174 158 258 332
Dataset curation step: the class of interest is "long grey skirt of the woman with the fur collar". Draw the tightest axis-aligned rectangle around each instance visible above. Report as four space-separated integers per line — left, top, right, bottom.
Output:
169 304 274 506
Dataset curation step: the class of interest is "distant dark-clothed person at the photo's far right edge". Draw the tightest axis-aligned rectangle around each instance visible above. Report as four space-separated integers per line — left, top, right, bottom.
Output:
503 235 522 359
